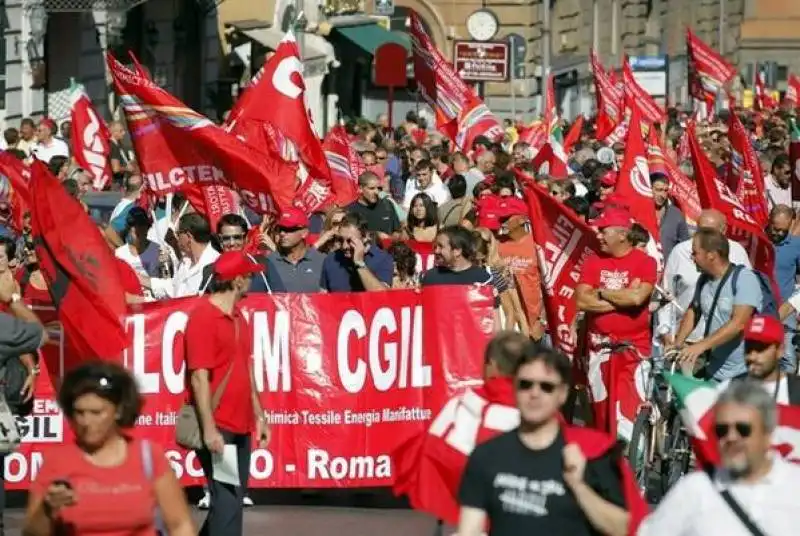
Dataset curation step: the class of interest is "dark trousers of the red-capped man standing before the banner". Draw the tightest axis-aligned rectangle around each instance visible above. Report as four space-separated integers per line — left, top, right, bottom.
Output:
196 430 250 536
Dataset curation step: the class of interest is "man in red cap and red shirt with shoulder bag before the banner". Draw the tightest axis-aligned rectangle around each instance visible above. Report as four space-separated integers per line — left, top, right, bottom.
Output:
185 251 269 536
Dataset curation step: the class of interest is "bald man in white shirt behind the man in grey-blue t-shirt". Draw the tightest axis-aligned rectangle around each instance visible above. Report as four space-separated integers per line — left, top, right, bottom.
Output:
656 209 752 344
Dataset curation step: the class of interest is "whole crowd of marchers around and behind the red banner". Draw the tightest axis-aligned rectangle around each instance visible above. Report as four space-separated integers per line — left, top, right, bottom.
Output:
0 99 800 536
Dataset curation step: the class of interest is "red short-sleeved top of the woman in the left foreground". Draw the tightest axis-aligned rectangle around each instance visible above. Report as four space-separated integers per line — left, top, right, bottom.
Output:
30 439 171 536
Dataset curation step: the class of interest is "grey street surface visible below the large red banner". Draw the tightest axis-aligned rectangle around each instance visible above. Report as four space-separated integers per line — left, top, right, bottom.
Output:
0 492 444 536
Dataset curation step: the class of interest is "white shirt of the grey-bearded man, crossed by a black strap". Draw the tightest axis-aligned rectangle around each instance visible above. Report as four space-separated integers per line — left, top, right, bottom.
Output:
637 456 800 536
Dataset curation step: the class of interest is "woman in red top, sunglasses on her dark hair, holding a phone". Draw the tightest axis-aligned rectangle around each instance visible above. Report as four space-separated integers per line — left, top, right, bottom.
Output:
23 361 196 536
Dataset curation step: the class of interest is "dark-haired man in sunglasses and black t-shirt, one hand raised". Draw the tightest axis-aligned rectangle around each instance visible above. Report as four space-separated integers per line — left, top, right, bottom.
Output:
458 345 629 536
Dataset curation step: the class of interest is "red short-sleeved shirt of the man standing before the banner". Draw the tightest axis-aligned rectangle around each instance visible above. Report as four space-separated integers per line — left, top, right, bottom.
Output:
184 299 255 434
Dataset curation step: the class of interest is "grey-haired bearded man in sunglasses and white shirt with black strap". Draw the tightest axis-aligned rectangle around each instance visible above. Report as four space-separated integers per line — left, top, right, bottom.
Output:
638 380 800 536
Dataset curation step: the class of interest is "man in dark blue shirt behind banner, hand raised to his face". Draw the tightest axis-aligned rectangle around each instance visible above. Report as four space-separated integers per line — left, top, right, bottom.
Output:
320 213 394 292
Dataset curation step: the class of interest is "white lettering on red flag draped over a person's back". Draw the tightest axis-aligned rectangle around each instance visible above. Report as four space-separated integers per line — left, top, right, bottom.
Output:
428 389 519 455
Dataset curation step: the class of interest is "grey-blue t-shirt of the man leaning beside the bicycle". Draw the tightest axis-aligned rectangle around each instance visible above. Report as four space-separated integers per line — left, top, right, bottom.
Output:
698 268 762 381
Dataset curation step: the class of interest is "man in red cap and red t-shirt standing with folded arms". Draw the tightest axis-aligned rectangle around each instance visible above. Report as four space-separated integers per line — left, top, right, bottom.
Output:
575 208 657 439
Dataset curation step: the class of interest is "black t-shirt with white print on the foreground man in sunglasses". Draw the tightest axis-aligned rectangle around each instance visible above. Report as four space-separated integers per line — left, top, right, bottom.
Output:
459 430 625 536
